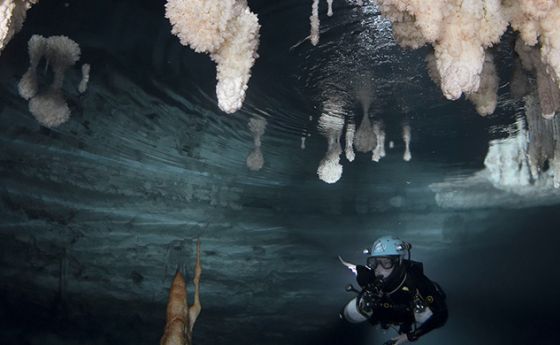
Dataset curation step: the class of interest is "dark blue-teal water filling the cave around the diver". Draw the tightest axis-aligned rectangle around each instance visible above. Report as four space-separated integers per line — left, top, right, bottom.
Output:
0 0 560 344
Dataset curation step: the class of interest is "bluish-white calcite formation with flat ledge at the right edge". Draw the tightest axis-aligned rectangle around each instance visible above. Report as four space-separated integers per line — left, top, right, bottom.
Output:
430 93 560 208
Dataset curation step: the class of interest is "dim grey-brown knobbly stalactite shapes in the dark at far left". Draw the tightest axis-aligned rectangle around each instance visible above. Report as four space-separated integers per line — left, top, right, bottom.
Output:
18 35 89 128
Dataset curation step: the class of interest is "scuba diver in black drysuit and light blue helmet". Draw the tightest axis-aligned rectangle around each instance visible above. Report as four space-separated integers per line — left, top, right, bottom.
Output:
339 236 448 345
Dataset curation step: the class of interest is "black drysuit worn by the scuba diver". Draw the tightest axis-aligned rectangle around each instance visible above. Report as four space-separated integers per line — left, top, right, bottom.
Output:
356 260 448 341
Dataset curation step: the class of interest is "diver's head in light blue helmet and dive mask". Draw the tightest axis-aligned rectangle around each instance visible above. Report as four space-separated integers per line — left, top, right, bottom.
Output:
367 236 410 279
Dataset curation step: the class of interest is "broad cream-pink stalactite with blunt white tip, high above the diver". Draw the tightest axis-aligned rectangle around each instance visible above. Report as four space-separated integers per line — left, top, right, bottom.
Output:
380 0 507 100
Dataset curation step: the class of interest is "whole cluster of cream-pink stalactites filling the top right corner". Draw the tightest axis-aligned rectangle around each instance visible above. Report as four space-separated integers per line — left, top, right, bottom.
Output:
377 0 560 115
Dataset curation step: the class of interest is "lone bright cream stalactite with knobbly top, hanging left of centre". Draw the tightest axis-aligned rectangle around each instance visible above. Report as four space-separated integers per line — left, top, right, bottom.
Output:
165 0 260 113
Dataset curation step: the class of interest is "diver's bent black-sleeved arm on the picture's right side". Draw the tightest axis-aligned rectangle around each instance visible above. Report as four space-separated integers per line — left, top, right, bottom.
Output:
407 275 448 341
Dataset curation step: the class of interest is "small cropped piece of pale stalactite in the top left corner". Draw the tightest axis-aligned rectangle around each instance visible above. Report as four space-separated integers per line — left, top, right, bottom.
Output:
0 0 39 53
